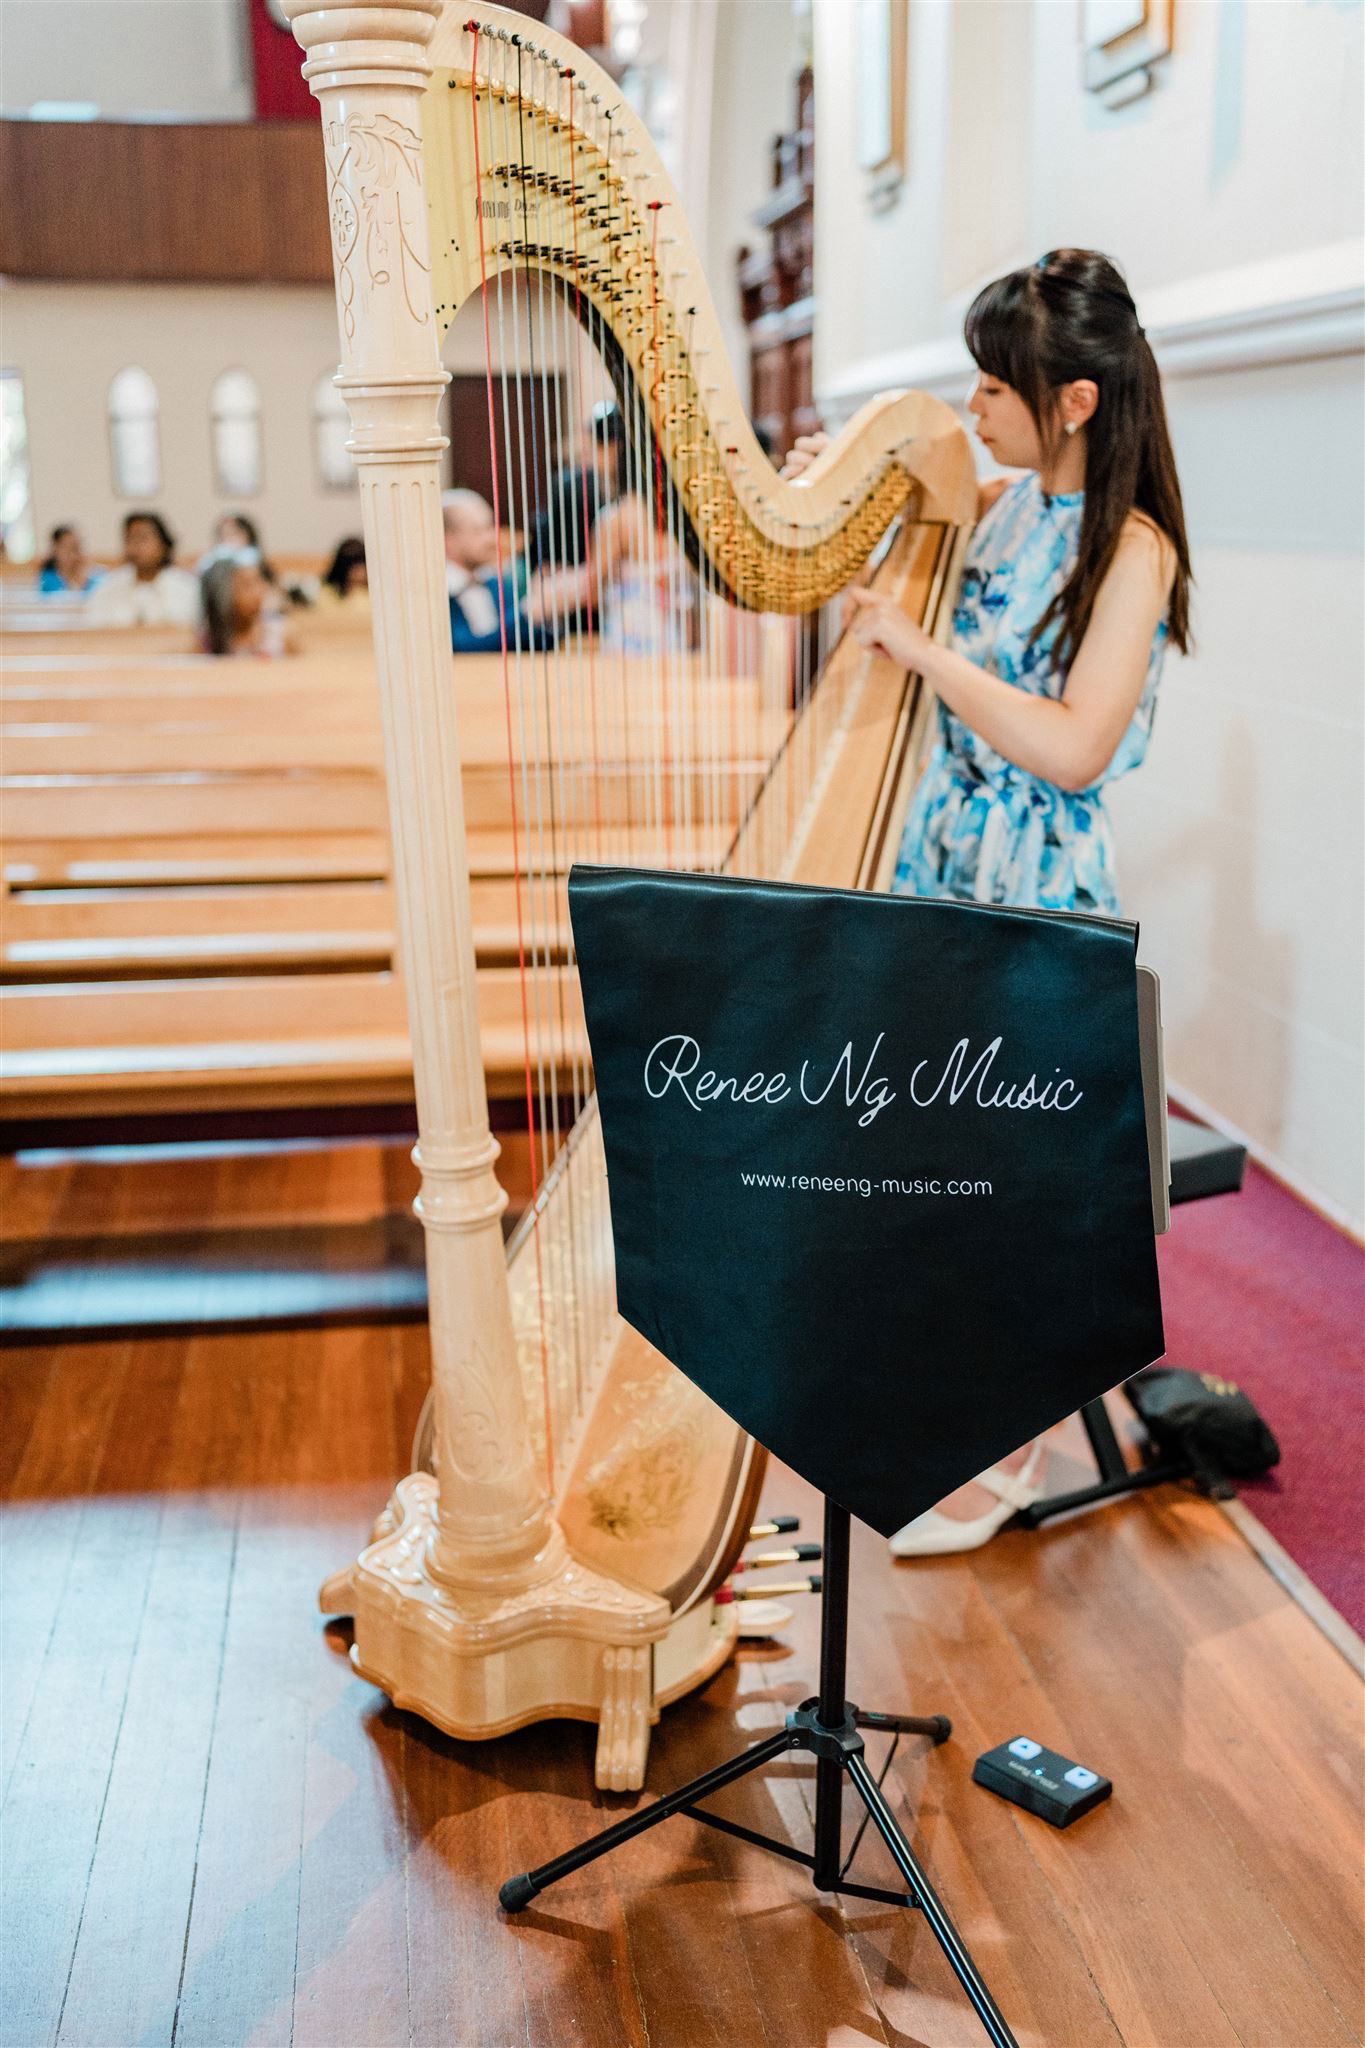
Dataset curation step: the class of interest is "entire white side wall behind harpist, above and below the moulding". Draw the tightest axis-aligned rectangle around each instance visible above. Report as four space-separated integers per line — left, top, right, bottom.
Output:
817 0 1365 1229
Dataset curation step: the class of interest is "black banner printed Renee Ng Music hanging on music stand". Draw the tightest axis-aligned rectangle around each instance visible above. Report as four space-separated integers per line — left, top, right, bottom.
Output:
569 868 1162 1536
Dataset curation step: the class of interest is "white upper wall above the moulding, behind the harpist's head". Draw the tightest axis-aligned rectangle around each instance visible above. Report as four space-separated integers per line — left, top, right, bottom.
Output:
814 0 1365 387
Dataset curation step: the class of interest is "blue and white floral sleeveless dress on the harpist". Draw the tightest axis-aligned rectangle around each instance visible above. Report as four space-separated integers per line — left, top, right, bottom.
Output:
890 473 1166 915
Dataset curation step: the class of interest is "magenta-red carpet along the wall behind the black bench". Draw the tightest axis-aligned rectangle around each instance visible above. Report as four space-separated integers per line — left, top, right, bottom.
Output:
1158 1165 1365 1634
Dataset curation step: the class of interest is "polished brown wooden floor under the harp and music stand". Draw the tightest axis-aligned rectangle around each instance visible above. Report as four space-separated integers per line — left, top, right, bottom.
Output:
0 1327 1361 2048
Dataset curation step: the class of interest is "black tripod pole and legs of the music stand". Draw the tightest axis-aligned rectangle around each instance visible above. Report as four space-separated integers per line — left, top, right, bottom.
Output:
497 1499 1017 2048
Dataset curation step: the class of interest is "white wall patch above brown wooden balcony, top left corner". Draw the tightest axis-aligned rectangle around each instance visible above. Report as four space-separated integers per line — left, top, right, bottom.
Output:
0 0 254 121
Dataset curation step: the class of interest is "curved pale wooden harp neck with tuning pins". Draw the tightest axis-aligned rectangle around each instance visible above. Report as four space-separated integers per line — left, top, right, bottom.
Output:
426 6 974 612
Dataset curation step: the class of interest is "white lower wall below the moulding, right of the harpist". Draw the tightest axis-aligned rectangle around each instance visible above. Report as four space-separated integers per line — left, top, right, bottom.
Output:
1113 356 1365 1227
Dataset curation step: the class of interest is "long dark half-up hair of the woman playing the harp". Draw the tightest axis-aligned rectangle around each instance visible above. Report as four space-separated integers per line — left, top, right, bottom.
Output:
966 250 1191 668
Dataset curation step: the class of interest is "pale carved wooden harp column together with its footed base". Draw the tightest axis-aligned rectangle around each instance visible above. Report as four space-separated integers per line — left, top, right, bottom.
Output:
284 0 669 1786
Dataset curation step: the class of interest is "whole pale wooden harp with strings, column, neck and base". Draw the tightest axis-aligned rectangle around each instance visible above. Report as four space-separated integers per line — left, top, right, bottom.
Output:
284 0 974 1788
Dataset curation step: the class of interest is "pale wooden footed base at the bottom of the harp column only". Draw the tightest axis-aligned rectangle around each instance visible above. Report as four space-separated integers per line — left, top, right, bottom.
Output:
319 1473 712 1792
